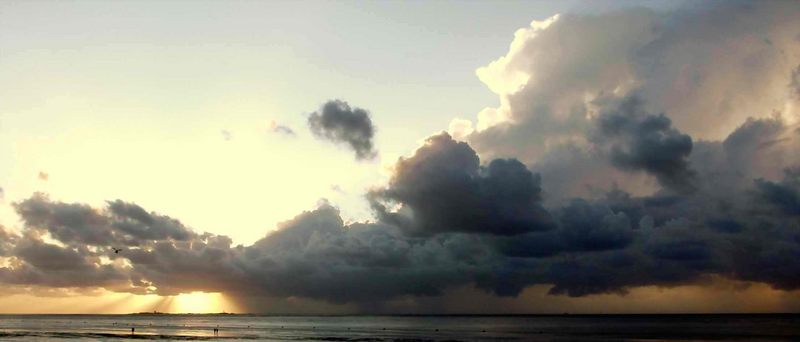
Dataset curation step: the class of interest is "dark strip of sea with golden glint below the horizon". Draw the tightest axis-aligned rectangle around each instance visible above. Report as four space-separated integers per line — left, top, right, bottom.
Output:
0 315 800 341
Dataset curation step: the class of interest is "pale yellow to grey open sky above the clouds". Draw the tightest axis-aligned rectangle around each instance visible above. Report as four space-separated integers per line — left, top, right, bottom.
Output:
0 1 580 243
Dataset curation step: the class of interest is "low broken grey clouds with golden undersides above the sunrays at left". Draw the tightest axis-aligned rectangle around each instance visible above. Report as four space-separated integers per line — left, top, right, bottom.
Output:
5 194 244 295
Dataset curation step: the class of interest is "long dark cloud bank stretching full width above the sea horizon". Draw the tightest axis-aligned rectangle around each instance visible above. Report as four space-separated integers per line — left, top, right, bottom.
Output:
0 113 800 303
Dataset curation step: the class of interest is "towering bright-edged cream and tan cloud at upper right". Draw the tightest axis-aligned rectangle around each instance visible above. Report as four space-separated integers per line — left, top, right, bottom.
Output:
460 1 800 195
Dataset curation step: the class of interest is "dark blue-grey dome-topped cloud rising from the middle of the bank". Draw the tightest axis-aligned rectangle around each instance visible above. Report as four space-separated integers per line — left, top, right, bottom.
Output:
371 133 550 235
